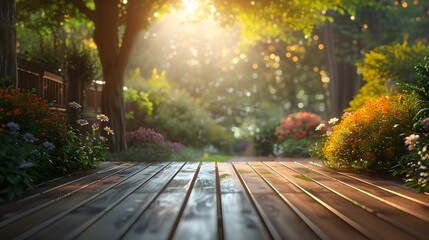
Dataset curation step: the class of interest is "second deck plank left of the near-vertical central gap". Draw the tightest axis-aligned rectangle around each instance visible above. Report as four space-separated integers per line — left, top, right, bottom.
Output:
120 162 199 239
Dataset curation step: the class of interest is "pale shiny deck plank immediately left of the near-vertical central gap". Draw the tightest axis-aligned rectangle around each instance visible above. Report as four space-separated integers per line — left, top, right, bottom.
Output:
174 162 218 240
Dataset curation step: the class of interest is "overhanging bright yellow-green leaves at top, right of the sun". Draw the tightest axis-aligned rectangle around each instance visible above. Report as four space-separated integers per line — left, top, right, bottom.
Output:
215 0 377 45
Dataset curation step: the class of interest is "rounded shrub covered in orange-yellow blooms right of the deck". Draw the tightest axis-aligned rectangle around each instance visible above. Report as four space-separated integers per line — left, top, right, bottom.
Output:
322 95 418 170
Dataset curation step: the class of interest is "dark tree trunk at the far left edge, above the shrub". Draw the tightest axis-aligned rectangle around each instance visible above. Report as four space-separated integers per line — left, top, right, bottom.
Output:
0 0 17 86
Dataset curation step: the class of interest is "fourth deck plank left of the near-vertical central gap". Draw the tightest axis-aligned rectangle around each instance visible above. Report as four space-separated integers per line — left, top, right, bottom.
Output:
30 163 167 239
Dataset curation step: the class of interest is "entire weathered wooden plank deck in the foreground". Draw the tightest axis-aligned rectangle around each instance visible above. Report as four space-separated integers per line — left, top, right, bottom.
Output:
0 161 429 240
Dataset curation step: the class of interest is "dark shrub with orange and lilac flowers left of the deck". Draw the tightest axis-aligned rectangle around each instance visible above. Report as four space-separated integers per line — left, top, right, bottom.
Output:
0 88 112 200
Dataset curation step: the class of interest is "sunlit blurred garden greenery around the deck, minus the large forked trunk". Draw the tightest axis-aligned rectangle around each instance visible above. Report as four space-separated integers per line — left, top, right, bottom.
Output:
0 0 429 199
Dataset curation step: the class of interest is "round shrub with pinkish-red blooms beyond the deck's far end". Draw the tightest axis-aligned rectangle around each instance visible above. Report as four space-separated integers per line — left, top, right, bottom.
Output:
273 112 326 156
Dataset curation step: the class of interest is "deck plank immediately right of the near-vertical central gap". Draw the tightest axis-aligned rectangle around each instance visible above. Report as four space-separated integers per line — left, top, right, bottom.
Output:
218 163 270 240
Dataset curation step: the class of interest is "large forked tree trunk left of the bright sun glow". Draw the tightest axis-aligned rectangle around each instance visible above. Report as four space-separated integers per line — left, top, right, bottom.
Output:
66 0 166 151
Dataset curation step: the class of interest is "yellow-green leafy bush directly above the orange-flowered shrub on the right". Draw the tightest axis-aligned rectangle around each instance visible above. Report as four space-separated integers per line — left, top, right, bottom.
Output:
347 39 426 111
